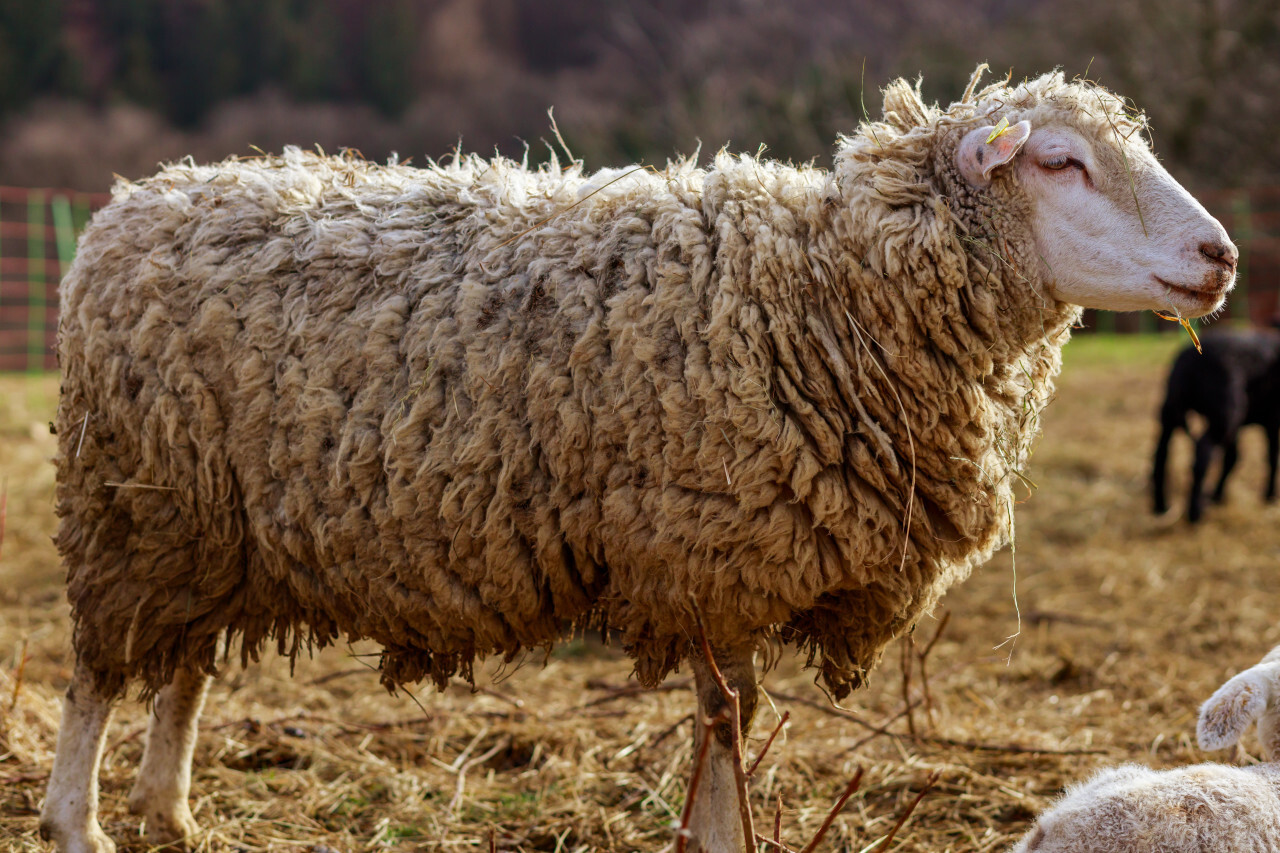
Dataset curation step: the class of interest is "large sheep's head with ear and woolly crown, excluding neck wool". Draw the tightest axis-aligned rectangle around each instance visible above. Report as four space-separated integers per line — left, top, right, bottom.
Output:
952 74 1238 316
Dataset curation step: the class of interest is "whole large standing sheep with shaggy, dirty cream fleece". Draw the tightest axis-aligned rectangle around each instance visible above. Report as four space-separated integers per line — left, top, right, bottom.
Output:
41 69 1235 853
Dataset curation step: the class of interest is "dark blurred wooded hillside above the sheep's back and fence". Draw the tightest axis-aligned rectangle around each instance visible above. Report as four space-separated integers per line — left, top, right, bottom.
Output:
0 0 1280 190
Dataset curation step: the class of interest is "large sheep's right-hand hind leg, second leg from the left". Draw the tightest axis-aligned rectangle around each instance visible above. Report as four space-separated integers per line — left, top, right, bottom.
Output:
129 667 210 845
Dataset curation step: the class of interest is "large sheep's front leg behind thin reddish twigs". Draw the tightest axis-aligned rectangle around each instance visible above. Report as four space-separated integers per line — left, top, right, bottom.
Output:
689 647 756 853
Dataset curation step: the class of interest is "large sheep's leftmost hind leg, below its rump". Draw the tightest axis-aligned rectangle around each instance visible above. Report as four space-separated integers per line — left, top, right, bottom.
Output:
40 663 115 853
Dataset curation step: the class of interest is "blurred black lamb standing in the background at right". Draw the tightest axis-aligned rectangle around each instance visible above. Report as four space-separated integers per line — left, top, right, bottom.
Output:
1152 329 1280 524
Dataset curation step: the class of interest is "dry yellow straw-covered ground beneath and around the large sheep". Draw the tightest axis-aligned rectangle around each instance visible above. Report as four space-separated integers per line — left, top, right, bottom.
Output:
0 336 1280 853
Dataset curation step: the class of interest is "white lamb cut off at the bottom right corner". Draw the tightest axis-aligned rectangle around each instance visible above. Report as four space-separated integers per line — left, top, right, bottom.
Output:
1011 647 1280 853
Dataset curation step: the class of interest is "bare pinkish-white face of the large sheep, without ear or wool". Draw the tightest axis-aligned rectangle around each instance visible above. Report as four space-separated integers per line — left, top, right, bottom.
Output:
1012 123 1236 318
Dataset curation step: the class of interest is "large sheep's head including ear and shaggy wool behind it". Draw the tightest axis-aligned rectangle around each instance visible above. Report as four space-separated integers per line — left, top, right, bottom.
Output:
836 65 1236 318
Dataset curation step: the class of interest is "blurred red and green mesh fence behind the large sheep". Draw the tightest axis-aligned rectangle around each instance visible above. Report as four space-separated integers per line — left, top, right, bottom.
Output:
0 187 1280 370
